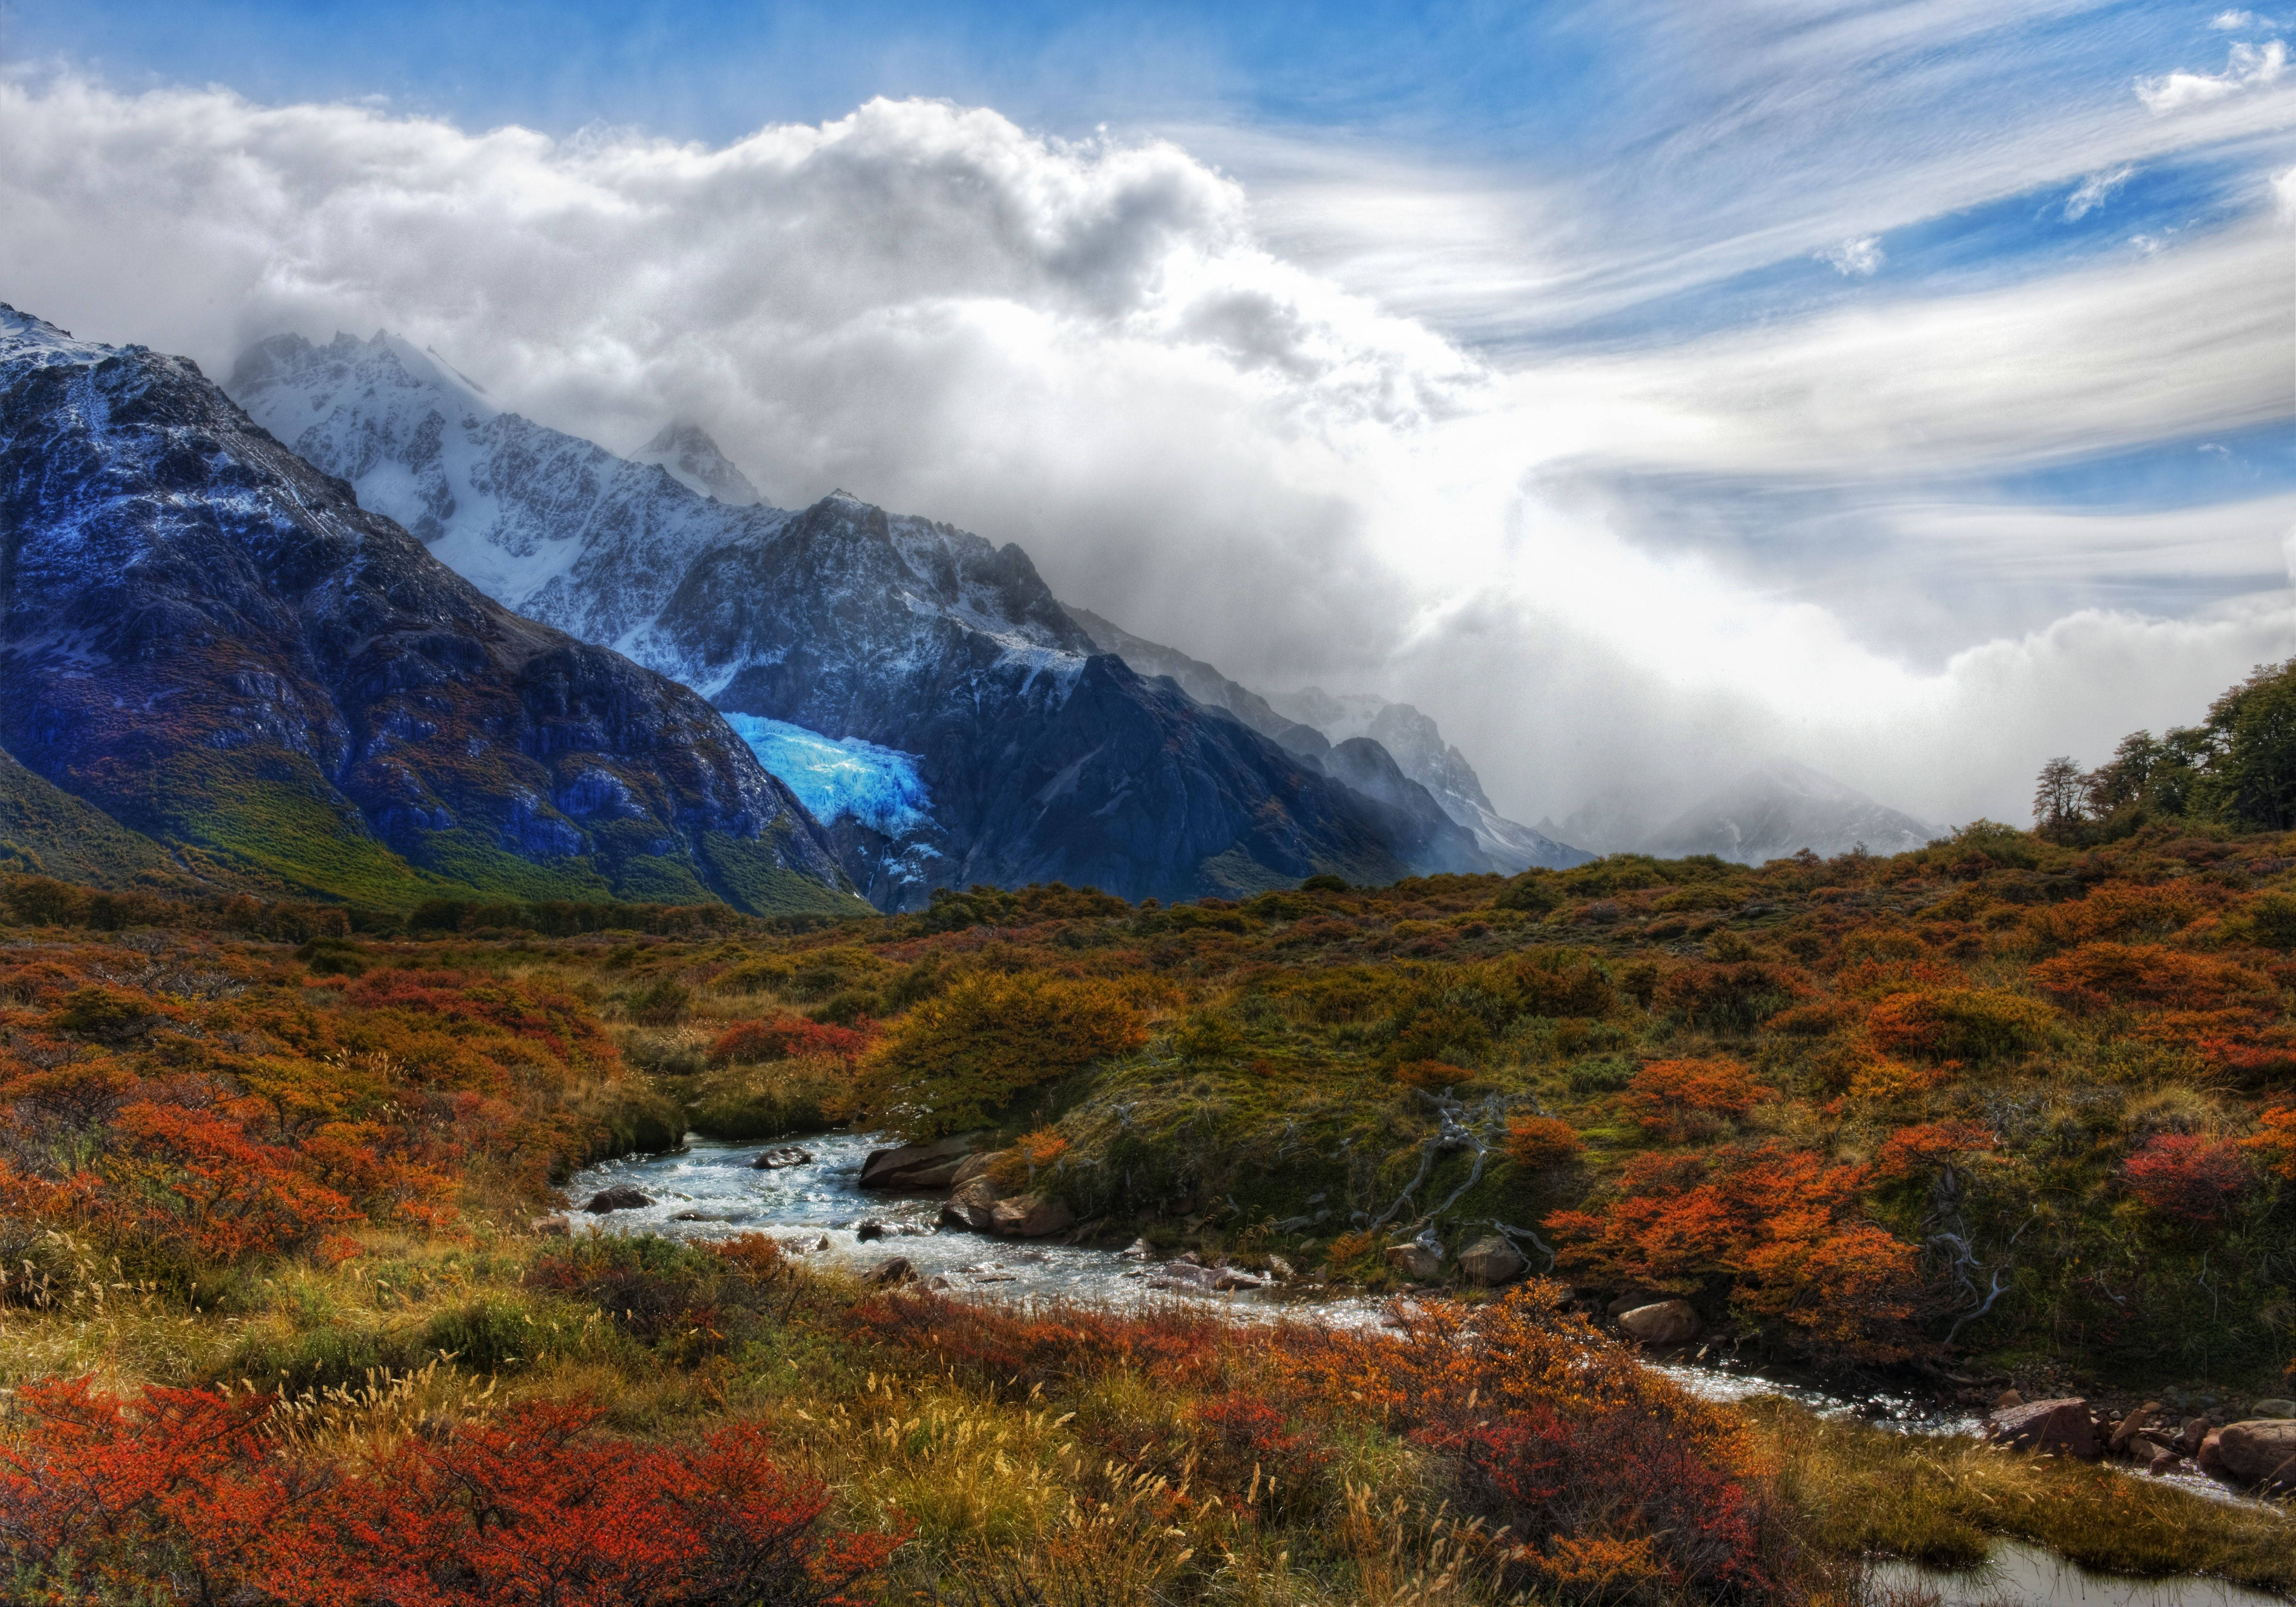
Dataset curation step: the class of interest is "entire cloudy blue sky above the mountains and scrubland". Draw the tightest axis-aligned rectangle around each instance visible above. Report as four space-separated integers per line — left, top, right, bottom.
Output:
0 0 2296 817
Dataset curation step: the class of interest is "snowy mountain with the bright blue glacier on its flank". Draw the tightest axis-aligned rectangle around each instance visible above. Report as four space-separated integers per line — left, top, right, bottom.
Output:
232 335 1437 909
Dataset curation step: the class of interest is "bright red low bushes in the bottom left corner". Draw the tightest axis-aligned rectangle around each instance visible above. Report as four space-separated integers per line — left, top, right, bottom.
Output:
0 1380 898 1607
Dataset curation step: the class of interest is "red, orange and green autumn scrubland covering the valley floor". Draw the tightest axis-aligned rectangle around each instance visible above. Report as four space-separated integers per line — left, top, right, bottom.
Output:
0 808 2296 1605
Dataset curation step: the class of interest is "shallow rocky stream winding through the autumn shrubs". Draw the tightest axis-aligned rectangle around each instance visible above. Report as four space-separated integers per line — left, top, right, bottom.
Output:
565 1132 2287 1607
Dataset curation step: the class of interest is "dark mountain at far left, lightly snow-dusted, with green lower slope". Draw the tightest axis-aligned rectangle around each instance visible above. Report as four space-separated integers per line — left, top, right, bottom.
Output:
0 308 854 912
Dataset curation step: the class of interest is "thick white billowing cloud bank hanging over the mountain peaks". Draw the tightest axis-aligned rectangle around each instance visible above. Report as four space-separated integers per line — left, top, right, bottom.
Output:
0 78 2296 819
